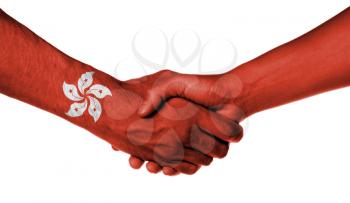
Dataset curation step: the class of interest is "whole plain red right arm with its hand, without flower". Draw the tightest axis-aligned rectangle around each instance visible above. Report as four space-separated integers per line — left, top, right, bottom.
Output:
139 8 350 122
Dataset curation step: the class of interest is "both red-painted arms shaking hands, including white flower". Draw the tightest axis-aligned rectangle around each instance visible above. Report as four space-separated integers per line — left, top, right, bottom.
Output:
0 8 350 176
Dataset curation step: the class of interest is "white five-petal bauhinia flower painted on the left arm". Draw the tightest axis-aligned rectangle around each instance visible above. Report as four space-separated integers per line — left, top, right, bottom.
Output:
63 72 112 122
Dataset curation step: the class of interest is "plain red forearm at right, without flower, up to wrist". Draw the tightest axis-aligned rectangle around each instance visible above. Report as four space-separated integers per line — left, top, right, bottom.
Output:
229 8 350 115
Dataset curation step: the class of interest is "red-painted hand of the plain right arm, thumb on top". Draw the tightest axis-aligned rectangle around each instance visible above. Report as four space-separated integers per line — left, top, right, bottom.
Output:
138 70 248 122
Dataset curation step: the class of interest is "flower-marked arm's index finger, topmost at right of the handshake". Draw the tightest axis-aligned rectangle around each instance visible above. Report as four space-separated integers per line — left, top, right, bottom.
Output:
197 110 243 142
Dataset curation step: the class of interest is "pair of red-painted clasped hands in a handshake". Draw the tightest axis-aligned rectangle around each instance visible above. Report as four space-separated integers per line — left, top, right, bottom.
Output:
104 70 245 176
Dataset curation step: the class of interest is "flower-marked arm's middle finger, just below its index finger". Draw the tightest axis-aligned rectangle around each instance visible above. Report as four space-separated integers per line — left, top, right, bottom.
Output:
191 126 229 158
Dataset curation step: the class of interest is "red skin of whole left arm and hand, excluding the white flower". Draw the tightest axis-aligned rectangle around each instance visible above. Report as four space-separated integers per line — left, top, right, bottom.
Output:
0 10 242 175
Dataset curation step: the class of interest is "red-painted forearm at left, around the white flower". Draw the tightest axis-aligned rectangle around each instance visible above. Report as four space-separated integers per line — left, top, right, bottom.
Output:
0 10 118 133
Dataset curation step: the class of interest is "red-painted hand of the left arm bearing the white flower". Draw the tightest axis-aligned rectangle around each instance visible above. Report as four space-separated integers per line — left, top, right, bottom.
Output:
103 77 242 175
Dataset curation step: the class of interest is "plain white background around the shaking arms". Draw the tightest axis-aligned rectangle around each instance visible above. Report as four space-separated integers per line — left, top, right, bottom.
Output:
0 0 350 203
